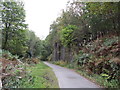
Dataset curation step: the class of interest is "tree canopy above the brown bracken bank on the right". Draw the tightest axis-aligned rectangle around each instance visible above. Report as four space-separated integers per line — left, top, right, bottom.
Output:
48 1 119 60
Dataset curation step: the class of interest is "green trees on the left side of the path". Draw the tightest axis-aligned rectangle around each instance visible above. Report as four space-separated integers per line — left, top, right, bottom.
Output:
0 0 43 57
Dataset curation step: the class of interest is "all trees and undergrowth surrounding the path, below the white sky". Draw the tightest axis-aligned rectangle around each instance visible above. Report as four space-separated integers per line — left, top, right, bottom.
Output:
0 1 120 87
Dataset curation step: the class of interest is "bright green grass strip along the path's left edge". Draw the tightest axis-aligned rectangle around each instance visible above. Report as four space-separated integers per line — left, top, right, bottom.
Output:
21 62 59 88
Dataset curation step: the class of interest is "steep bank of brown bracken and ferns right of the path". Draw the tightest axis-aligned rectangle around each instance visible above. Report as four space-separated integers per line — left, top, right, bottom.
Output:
55 35 120 87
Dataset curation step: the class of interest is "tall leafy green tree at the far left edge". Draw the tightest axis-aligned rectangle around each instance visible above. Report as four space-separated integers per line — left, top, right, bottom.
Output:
1 0 27 54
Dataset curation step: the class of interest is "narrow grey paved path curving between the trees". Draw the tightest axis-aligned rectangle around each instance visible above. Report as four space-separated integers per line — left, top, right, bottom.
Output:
44 62 99 88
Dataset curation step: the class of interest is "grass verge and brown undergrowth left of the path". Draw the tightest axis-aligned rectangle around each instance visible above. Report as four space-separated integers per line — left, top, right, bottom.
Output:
0 51 59 88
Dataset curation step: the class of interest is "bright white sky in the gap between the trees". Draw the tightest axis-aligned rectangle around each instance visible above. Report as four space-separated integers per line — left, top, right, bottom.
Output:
23 0 68 39
